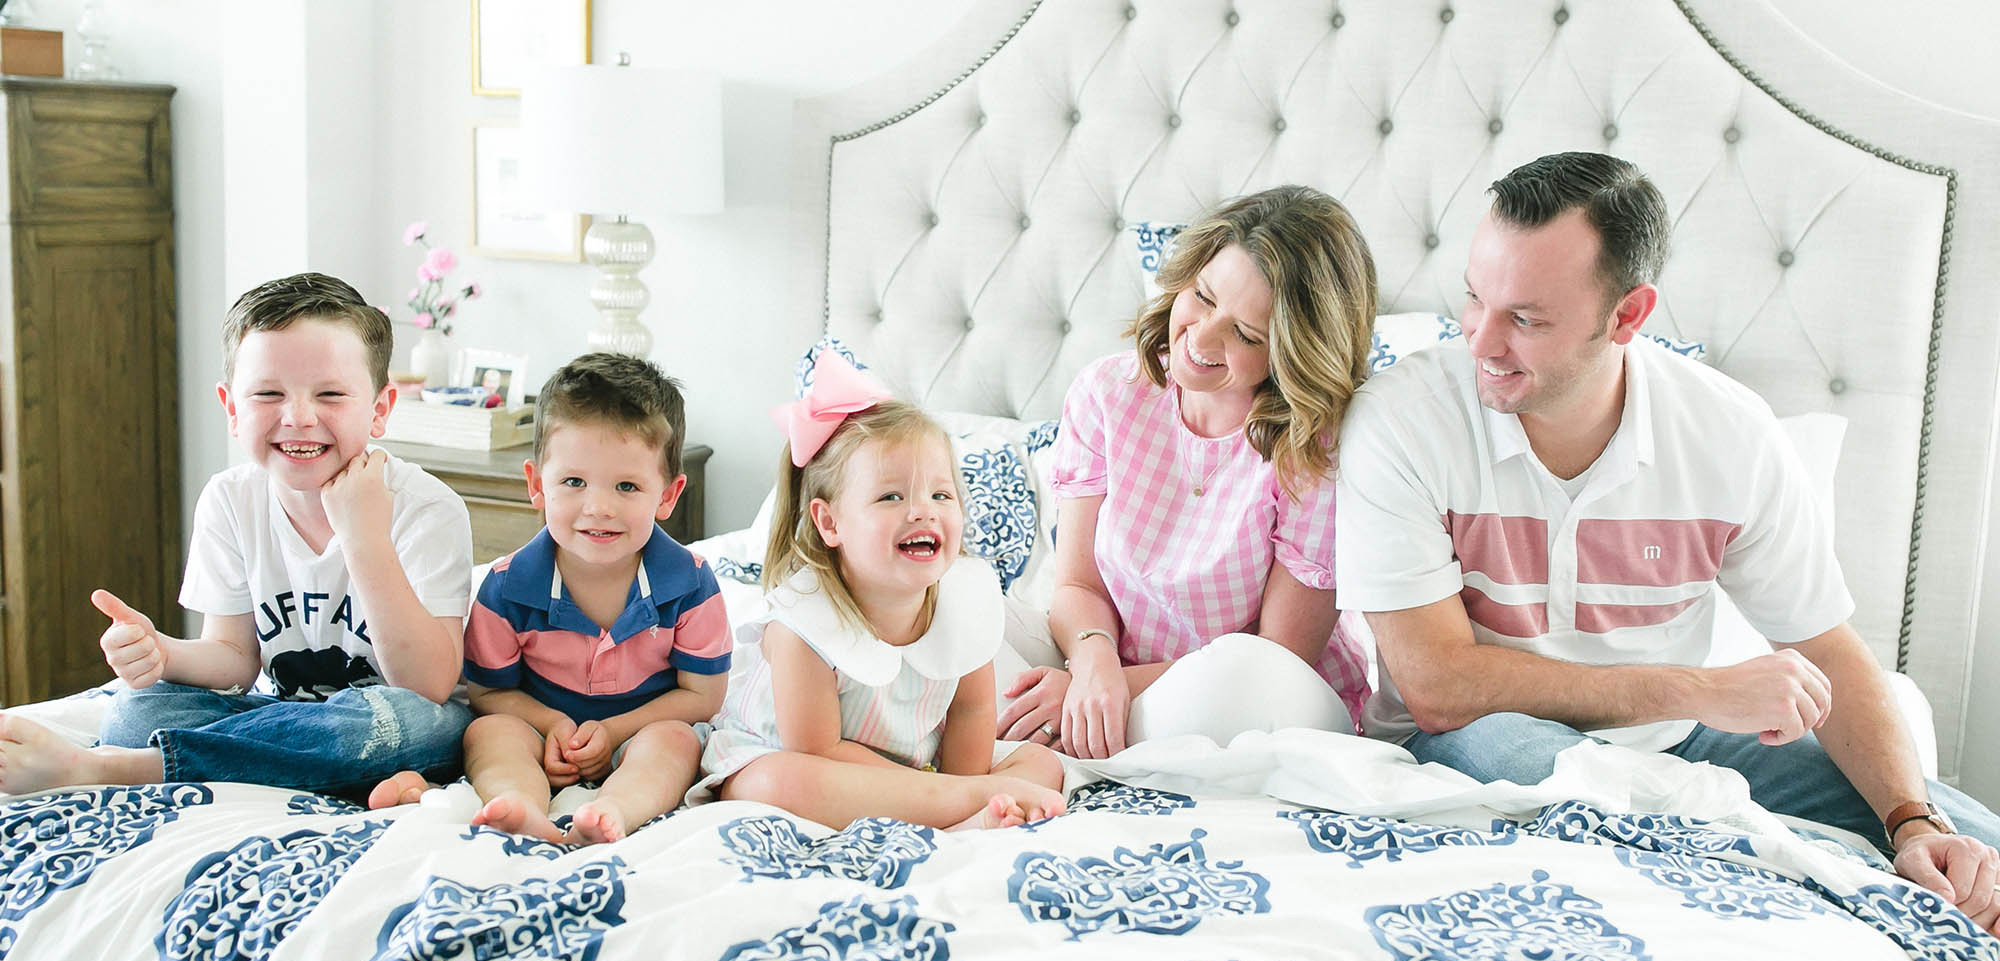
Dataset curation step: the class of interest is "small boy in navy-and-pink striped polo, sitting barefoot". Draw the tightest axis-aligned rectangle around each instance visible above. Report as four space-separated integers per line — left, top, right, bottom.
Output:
398 354 732 843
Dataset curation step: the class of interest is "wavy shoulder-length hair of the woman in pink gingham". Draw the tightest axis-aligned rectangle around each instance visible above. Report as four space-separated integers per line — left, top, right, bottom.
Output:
1126 184 1376 497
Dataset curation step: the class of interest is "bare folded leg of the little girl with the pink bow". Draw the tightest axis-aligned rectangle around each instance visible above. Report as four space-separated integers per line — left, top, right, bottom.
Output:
722 751 1064 829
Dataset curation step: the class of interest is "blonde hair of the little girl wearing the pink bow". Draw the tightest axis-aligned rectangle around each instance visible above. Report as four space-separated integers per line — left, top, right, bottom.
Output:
762 400 966 633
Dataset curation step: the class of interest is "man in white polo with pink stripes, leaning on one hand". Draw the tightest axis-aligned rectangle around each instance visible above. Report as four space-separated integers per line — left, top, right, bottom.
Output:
1334 152 2000 931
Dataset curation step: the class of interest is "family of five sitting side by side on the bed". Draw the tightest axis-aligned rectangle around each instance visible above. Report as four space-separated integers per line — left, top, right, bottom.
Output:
0 152 2000 931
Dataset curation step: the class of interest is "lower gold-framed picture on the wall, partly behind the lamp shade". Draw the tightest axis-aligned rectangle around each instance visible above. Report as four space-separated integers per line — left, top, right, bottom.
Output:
472 124 588 264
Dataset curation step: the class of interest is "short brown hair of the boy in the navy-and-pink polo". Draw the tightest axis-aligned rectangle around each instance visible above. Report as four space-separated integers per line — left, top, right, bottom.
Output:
534 352 688 483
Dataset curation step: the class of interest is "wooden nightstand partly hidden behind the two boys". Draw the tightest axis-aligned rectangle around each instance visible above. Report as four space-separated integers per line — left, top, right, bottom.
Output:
376 440 714 565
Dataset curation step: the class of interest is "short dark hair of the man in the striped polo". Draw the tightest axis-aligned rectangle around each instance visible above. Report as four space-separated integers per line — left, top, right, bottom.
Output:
1492 152 1674 304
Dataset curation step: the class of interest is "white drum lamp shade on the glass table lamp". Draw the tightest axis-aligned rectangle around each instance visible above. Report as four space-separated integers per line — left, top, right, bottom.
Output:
520 66 722 214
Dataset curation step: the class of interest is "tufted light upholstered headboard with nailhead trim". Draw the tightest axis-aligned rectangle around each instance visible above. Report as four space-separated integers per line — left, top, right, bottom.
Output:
786 0 2000 777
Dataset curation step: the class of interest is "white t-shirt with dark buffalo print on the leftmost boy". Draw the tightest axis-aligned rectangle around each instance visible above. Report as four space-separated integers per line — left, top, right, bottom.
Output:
180 446 472 701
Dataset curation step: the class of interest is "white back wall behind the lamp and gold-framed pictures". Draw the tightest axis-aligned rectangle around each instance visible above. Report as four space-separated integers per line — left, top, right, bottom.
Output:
368 0 984 531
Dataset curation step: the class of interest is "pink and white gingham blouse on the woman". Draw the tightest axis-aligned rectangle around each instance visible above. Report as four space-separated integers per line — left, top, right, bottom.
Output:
1050 350 1368 719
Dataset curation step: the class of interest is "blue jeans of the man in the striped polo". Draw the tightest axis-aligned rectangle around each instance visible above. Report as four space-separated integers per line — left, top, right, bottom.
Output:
1402 713 2000 853
